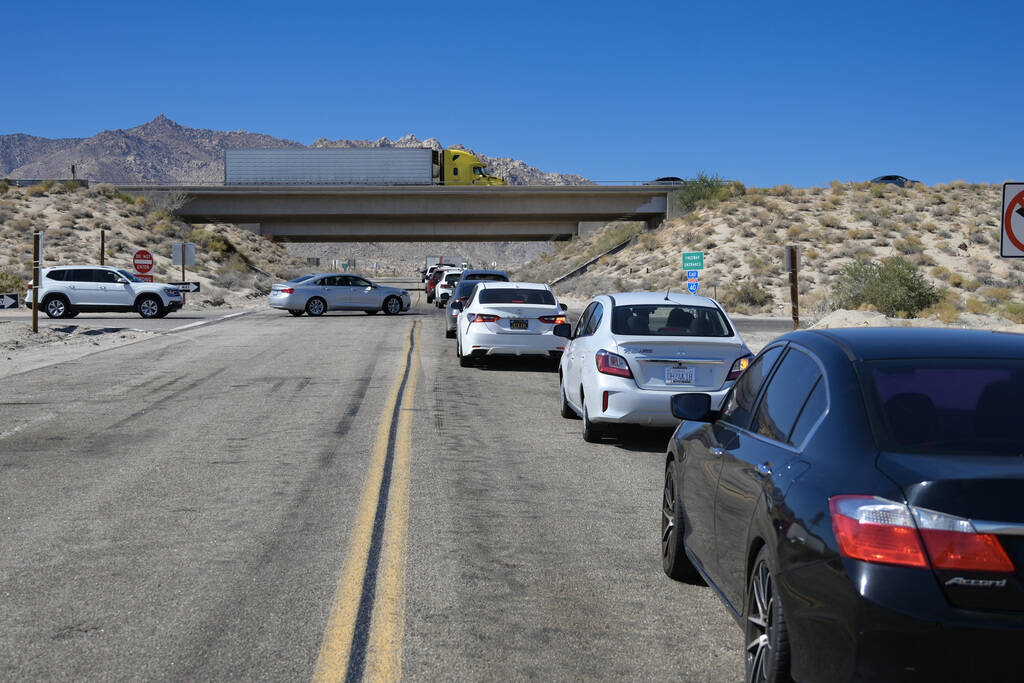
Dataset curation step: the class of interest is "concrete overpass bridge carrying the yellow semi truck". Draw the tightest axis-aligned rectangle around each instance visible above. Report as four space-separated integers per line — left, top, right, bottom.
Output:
121 185 678 242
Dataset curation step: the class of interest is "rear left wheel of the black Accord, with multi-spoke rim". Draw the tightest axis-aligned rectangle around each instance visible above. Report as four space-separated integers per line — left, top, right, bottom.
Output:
743 546 793 683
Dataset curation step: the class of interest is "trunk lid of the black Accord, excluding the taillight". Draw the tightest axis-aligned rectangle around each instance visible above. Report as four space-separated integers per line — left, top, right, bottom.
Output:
878 453 1024 611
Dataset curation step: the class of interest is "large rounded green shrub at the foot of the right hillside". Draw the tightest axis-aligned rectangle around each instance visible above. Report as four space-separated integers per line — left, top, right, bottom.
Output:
833 256 942 317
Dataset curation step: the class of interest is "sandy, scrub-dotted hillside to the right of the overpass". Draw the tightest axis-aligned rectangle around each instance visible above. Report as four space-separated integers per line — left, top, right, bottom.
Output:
516 181 1024 324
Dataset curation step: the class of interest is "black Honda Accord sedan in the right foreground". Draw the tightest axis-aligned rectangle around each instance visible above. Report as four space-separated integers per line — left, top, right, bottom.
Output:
662 328 1024 681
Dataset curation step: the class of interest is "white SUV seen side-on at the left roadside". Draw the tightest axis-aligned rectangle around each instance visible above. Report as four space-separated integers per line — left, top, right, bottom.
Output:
26 265 182 317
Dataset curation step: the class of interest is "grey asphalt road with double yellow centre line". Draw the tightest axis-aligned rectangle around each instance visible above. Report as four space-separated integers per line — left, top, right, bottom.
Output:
0 305 774 681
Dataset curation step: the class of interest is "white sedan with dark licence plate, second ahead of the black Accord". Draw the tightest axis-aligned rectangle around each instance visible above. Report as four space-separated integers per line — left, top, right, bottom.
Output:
452 282 565 368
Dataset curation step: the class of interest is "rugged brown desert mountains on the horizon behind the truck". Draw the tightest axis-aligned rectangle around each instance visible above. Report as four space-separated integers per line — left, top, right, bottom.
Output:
0 115 590 185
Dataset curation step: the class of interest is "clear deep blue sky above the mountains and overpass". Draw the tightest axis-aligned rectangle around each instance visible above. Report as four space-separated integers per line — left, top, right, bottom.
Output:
0 0 1024 186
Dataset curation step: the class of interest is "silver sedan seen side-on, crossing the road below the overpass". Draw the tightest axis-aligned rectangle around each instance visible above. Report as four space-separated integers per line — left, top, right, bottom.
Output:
268 272 412 316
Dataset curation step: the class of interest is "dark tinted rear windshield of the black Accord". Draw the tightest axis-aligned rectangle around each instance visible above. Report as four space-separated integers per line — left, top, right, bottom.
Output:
863 358 1024 455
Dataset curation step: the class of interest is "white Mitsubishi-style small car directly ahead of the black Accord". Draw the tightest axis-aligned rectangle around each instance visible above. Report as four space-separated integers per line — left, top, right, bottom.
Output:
558 292 754 441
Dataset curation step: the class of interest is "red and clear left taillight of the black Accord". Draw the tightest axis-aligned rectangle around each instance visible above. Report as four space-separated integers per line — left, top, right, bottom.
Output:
828 496 1014 571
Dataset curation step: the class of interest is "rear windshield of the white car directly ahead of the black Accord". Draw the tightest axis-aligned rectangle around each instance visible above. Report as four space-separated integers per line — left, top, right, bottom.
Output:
611 303 732 337
